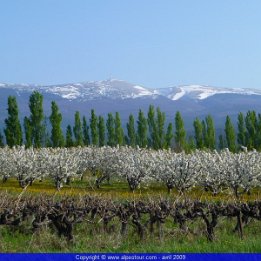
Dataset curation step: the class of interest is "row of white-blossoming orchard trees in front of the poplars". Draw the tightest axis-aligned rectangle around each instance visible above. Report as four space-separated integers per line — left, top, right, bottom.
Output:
0 146 261 197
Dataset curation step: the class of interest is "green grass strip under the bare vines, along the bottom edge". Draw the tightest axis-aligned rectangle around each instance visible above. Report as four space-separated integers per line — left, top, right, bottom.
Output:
0 213 261 253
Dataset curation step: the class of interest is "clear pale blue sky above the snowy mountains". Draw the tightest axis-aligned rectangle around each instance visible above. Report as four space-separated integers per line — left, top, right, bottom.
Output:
0 0 261 88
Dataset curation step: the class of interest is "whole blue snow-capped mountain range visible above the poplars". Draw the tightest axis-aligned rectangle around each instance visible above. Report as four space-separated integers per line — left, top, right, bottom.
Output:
0 79 261 128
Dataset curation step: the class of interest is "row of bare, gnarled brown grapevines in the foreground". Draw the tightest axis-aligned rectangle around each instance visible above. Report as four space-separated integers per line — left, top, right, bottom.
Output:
0 193 261 251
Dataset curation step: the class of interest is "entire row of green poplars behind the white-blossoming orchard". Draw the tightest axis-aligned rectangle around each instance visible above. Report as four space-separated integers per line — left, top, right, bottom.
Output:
0 91 261 152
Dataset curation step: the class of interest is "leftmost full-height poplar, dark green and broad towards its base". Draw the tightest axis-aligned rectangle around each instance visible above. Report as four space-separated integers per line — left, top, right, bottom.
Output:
4 96 23 147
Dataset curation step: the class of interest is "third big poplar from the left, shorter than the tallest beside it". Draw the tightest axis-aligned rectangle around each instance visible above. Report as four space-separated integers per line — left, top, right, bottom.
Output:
49 101 64 148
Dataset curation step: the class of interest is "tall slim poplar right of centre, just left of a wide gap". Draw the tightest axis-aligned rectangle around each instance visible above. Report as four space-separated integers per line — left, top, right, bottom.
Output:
175 111 186 151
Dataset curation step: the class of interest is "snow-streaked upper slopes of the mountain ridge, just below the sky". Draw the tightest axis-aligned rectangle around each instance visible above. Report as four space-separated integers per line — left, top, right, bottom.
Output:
0 79 261 101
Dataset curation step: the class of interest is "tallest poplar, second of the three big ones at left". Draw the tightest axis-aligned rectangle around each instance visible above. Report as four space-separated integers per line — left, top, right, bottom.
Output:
29 91 44 148
